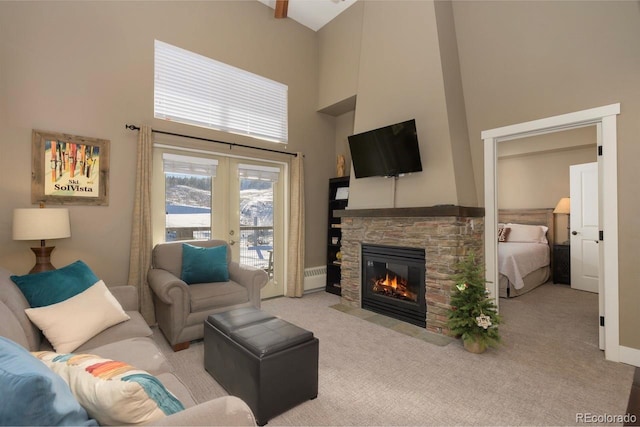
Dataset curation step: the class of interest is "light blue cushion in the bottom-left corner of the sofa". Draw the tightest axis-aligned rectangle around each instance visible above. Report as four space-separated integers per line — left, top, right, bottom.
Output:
0 337 98 426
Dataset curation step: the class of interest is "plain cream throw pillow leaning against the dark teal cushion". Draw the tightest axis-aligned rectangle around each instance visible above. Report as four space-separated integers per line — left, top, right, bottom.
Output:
25 280 130 353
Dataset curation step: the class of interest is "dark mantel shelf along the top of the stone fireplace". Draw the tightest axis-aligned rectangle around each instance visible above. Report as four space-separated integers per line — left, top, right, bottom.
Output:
333 205 484 218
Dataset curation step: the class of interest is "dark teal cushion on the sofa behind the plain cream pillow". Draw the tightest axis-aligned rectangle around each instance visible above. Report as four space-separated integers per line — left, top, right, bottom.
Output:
11 260 100 308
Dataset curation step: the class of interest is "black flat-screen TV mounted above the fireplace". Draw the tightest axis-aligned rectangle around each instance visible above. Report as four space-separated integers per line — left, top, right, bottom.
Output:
348 119 422 178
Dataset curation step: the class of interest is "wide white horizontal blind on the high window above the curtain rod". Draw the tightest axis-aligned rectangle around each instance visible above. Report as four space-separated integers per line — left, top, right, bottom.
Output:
154 40 288 143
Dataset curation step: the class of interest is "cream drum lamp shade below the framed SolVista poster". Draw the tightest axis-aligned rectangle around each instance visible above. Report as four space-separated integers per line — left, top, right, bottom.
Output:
13 208 71 240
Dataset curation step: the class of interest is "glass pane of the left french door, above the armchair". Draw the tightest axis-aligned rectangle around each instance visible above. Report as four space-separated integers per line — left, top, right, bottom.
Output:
165 173 212 242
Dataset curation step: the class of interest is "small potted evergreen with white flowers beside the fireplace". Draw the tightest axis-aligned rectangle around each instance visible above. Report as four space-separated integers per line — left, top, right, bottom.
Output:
448 252 501 353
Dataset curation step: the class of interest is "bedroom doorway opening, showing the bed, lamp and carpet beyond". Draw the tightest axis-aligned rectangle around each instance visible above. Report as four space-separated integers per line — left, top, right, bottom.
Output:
496 126 599 351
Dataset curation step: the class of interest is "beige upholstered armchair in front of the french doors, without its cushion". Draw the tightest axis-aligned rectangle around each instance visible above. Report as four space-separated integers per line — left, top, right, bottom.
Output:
147 240 268 351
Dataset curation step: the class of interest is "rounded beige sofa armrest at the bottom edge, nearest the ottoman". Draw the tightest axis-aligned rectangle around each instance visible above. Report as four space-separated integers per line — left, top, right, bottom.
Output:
153 396 256 426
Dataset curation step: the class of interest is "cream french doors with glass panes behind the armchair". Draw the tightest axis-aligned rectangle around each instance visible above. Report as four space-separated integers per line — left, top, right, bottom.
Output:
152 149 285 298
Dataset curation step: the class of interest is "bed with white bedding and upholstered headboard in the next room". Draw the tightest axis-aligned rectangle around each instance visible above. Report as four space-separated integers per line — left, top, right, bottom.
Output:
498 209 554 298
